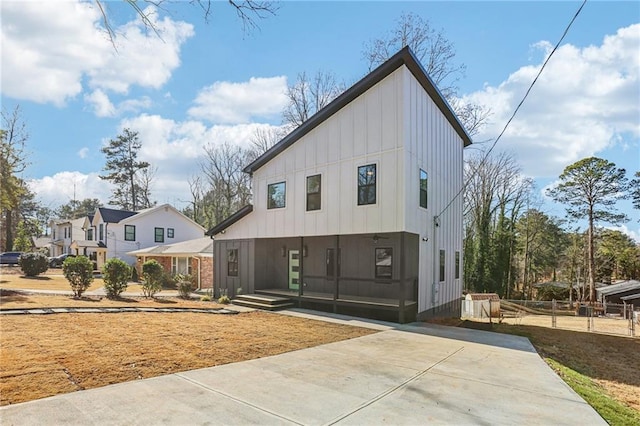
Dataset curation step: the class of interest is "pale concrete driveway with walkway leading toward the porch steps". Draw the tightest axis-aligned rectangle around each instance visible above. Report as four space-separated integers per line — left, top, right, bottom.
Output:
0 310 606 426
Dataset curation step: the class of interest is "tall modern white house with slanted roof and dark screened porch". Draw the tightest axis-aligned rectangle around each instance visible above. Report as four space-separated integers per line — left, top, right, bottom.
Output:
207 48 471 322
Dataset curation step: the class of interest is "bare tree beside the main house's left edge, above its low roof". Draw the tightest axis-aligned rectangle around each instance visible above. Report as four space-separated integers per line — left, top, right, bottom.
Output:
200 142 251 225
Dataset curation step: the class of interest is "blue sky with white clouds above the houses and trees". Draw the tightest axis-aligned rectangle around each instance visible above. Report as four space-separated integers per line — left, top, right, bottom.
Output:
0 1 640 241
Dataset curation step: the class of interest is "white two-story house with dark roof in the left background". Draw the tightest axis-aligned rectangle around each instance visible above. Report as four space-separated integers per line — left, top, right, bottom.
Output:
85 204 205 269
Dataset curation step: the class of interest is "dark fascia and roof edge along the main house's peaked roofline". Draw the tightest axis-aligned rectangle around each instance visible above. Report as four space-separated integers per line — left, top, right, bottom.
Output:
244 46 471 174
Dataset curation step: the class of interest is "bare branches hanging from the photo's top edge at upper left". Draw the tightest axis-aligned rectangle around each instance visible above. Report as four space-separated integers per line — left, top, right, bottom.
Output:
93 0 278 47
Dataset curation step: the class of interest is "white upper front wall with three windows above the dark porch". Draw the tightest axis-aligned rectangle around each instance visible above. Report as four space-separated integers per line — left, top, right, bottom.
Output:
216 67 405 240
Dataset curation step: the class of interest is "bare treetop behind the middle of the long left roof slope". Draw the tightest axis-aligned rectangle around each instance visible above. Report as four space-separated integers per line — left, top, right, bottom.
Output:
282 71 346 127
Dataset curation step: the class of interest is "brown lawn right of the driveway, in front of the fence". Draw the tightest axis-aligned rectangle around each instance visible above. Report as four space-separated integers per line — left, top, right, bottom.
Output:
462 317 640 412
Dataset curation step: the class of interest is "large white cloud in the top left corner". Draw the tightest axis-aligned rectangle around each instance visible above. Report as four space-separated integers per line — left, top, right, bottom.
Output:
0 1 194 108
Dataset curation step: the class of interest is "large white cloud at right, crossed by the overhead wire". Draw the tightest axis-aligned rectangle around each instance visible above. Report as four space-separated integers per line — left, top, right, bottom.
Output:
463 24 640 177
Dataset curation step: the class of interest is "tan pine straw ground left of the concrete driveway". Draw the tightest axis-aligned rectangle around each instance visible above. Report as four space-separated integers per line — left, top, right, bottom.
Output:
0 301 375 405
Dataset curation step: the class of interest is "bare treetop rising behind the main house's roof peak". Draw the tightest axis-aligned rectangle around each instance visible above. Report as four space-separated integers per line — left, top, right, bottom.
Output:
363 13 491 136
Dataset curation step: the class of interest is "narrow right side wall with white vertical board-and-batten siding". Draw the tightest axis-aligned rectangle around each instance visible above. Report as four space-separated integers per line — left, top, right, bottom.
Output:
402 68 464 312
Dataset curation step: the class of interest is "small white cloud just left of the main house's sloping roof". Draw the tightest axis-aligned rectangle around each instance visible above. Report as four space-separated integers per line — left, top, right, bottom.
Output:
189 76 287 124
